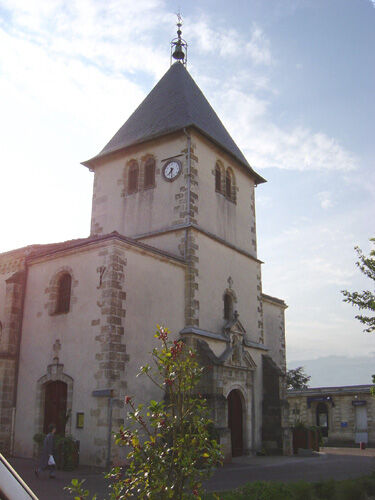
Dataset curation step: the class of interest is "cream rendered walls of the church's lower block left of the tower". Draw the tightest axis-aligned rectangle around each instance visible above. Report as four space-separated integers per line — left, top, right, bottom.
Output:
12 237 185 465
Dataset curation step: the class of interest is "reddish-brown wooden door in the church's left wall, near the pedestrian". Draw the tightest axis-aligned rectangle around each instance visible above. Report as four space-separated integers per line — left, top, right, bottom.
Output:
43 380 67 435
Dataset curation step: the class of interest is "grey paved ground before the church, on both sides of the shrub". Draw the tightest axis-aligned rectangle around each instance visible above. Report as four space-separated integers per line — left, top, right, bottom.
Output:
7 448 375 500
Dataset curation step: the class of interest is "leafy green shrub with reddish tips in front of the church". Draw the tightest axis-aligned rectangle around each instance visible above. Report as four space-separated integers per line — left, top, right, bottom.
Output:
68 327 222 500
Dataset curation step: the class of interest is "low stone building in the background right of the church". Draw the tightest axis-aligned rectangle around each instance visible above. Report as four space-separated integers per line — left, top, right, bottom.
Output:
287 385 375 446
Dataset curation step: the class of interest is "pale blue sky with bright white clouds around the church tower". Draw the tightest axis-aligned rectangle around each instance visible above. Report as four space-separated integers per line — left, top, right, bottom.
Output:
0 0 375 386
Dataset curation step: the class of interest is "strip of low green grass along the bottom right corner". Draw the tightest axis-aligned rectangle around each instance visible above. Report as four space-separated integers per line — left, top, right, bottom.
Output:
204 472 375 500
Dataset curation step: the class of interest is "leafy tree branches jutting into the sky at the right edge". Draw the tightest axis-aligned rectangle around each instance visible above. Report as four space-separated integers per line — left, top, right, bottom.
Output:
341 238 375 333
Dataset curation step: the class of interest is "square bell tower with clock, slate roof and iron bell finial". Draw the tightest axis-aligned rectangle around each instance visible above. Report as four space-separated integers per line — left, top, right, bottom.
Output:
83 20 265 341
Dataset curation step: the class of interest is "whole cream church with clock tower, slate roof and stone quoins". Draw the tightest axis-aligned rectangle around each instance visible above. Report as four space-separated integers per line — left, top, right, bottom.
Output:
0 25 288 466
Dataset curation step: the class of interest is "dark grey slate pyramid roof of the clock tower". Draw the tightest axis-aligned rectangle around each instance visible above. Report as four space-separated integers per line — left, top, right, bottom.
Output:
83 62 265 183
